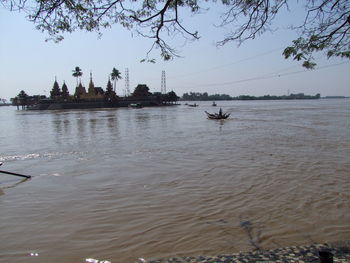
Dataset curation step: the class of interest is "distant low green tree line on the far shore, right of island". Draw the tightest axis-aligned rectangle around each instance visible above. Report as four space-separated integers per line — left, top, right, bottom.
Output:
181 92 321 101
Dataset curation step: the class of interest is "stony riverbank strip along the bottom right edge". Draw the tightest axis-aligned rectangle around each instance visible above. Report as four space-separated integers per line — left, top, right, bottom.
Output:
135 240 350 263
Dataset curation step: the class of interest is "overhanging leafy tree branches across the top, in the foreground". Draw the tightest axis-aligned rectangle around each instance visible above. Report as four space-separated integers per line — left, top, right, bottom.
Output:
1 0 350 68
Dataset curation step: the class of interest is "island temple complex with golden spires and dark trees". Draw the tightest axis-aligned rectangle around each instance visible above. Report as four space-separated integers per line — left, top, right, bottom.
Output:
12 79 179 110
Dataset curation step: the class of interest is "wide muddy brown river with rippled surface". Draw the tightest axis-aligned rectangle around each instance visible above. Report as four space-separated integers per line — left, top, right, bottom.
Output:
0 99 350 263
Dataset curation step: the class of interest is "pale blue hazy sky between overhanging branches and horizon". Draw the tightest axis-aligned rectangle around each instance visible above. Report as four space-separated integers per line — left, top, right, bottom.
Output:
0 1 350 100
